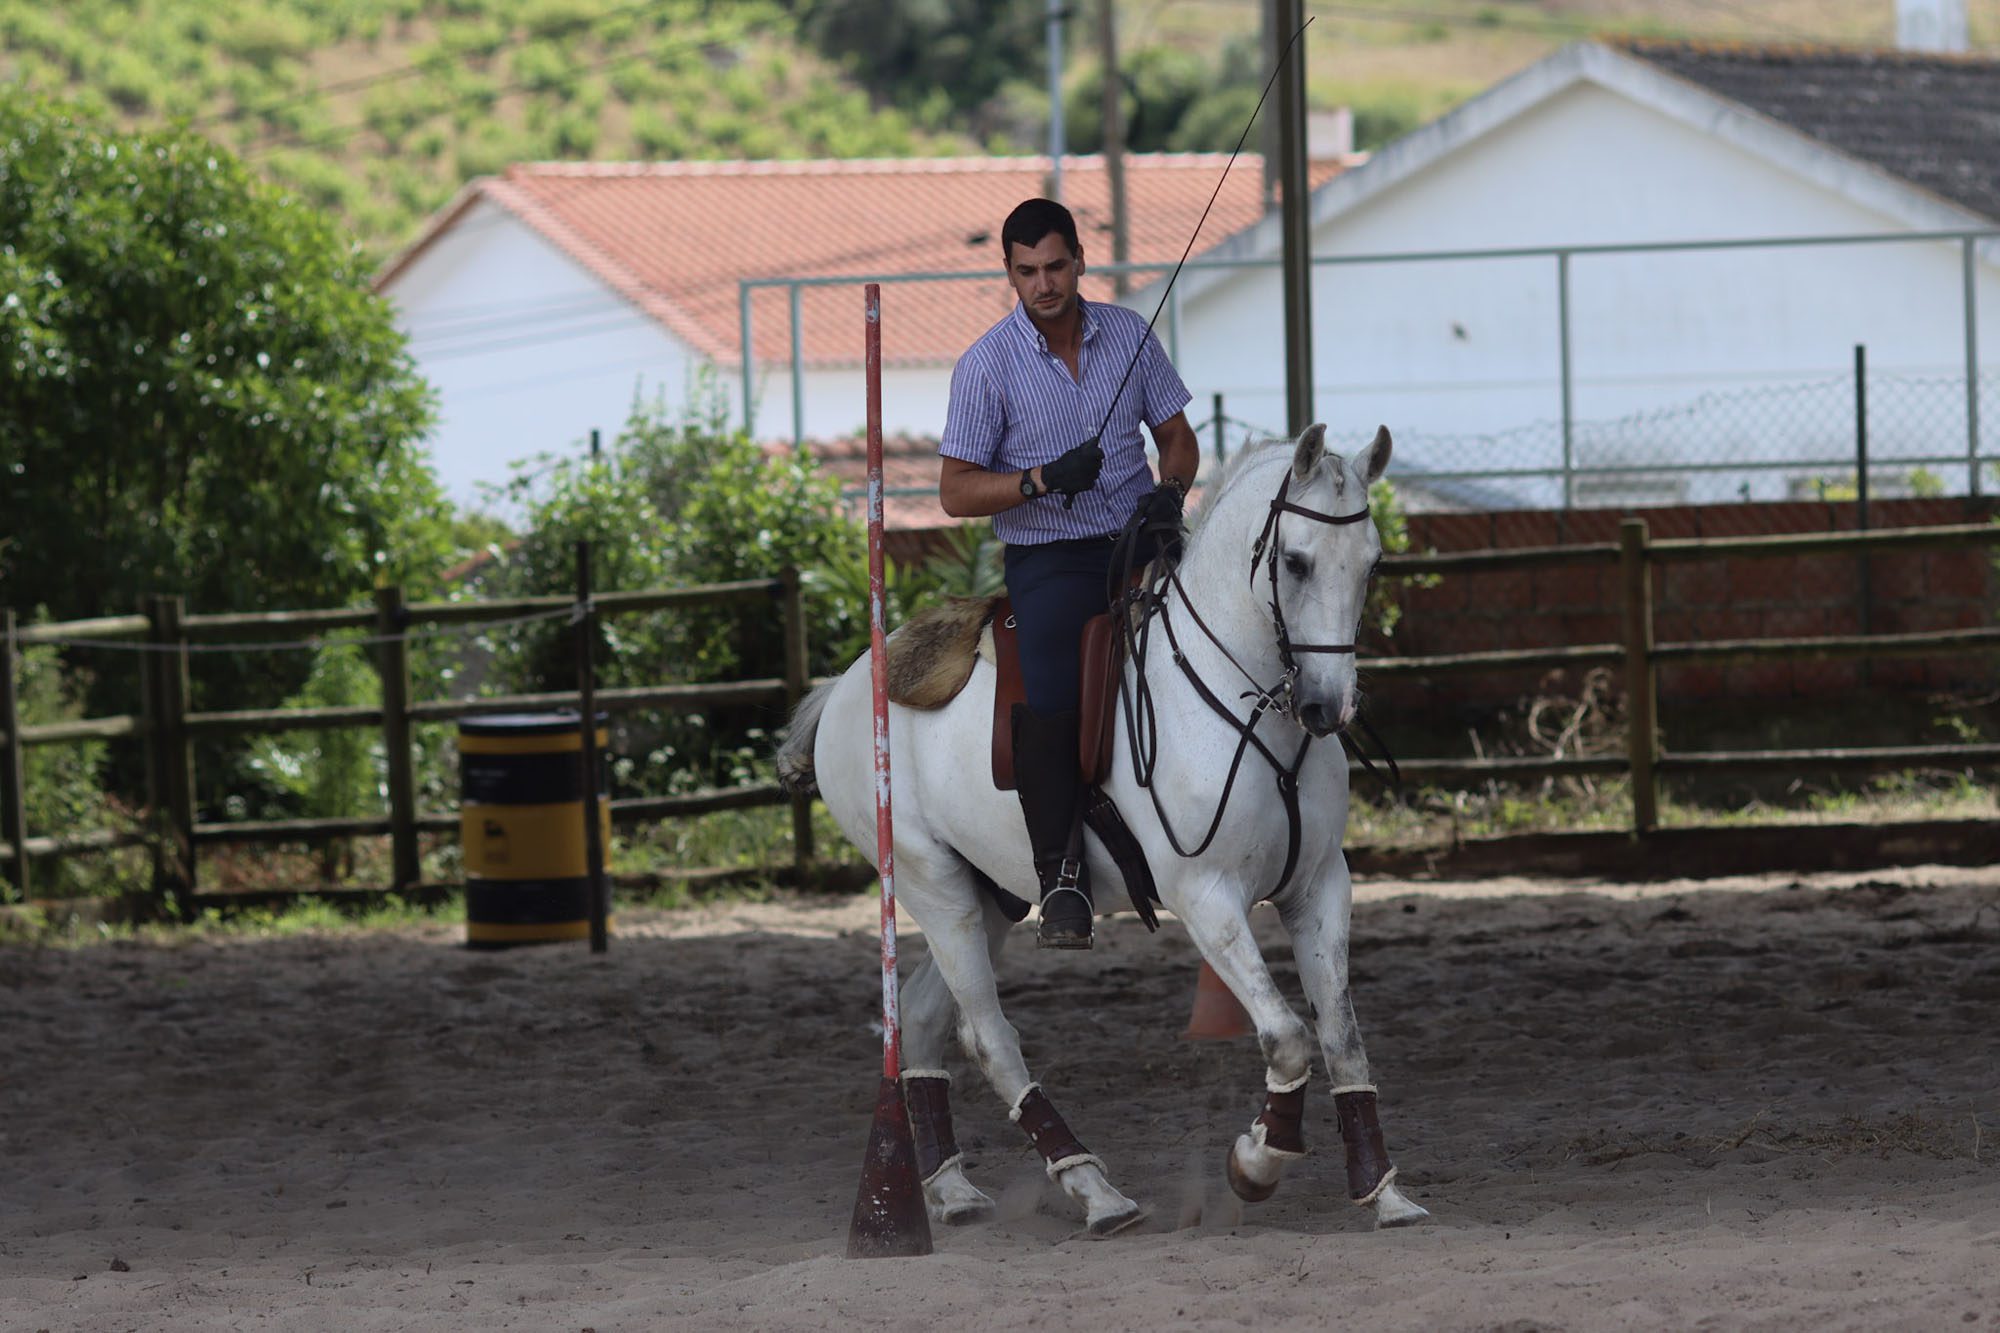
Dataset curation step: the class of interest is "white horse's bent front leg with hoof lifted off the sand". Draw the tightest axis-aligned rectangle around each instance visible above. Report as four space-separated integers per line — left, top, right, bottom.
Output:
1184 883 1312 1203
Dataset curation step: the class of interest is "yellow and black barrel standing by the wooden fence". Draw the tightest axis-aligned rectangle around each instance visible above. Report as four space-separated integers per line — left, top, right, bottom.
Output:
458 713 612 949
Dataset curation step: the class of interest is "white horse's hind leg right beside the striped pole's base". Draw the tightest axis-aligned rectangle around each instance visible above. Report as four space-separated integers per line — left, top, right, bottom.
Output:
902 895 1014 1225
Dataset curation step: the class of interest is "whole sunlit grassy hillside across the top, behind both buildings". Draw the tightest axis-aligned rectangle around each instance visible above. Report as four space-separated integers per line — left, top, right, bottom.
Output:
0 0 2000 254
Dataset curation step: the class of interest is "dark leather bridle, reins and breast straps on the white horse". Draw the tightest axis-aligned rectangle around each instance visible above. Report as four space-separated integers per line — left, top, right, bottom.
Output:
1112 466 1402 897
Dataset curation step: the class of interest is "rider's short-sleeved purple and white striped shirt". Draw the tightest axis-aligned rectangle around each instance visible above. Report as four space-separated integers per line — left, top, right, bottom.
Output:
938 298 1194 546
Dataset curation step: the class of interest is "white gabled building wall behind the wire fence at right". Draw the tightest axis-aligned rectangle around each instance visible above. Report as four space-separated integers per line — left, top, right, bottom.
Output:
1180 84 2000 502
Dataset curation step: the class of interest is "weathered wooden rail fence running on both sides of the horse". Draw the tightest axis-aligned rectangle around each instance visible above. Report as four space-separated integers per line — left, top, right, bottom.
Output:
0 518 2000 897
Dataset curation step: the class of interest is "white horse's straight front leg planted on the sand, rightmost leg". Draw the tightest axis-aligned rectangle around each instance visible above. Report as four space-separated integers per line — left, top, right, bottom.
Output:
1278 857 1430 1227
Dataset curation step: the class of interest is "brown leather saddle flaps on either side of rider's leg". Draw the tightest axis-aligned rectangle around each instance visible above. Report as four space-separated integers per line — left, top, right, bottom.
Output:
992 596 1160 931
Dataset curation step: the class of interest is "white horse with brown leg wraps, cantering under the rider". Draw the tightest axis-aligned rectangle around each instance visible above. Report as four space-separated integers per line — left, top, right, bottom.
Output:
778 426 1426 1235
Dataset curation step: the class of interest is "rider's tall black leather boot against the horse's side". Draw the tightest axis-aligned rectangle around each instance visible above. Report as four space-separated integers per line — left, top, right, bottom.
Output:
1014 705 1092 949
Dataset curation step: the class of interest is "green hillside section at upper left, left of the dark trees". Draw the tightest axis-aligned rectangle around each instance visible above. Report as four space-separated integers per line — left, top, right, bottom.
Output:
0 0 966 252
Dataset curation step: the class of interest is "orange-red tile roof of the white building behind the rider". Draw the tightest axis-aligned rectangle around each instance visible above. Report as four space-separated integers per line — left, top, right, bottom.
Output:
376 154 1346 368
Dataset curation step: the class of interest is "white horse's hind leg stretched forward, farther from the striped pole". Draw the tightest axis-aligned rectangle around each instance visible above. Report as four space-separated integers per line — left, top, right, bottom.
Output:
920 883 1144 1235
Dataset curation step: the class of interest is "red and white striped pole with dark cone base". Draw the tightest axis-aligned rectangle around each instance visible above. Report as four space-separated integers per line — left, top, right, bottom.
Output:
848 282 930 1259
